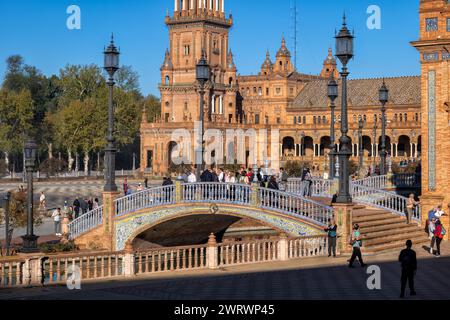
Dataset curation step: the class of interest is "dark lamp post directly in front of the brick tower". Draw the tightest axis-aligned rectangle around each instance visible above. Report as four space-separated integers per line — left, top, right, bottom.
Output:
196 49 211 181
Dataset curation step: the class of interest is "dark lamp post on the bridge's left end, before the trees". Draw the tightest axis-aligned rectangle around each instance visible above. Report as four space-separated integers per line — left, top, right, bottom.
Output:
103 36 120 192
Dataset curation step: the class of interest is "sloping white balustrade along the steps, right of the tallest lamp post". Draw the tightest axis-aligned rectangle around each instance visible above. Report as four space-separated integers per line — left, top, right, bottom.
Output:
350 184 421 221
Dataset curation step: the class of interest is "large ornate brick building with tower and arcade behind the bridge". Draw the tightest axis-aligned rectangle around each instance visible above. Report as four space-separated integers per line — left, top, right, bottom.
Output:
141 0 422 174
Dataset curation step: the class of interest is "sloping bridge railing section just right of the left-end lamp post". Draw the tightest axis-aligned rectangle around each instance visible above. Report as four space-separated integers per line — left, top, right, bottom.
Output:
114 185 175 217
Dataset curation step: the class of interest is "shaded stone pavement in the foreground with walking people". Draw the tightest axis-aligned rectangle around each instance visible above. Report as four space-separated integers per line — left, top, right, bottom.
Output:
0 243 450 300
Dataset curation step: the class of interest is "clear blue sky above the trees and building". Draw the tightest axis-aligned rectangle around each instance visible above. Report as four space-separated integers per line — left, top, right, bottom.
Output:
0 0 420 95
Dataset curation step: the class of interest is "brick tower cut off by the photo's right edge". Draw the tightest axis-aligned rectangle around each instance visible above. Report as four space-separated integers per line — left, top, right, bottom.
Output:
412 0 450 235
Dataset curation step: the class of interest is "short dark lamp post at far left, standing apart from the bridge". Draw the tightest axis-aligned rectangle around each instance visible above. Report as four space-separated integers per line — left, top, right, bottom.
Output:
21 138 39 253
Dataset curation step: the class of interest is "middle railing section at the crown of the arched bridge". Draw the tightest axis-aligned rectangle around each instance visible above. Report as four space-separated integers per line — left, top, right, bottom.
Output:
181 182 252 204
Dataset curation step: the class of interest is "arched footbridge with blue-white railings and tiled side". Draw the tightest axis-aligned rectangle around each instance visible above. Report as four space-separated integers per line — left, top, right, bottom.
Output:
68 182 334 250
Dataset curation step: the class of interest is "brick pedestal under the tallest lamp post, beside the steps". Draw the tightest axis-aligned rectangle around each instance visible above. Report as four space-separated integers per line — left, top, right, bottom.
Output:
333 203 354 254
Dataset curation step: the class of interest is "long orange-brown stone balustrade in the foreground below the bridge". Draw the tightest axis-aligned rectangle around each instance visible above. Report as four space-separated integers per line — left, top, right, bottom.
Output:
0 234 327 289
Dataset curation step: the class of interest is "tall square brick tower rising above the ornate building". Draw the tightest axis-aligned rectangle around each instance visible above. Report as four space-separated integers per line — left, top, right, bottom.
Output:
159 0 237 123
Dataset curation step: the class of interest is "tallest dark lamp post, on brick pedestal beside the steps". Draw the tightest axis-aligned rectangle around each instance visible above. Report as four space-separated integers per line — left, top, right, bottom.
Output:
335 15 354 204
